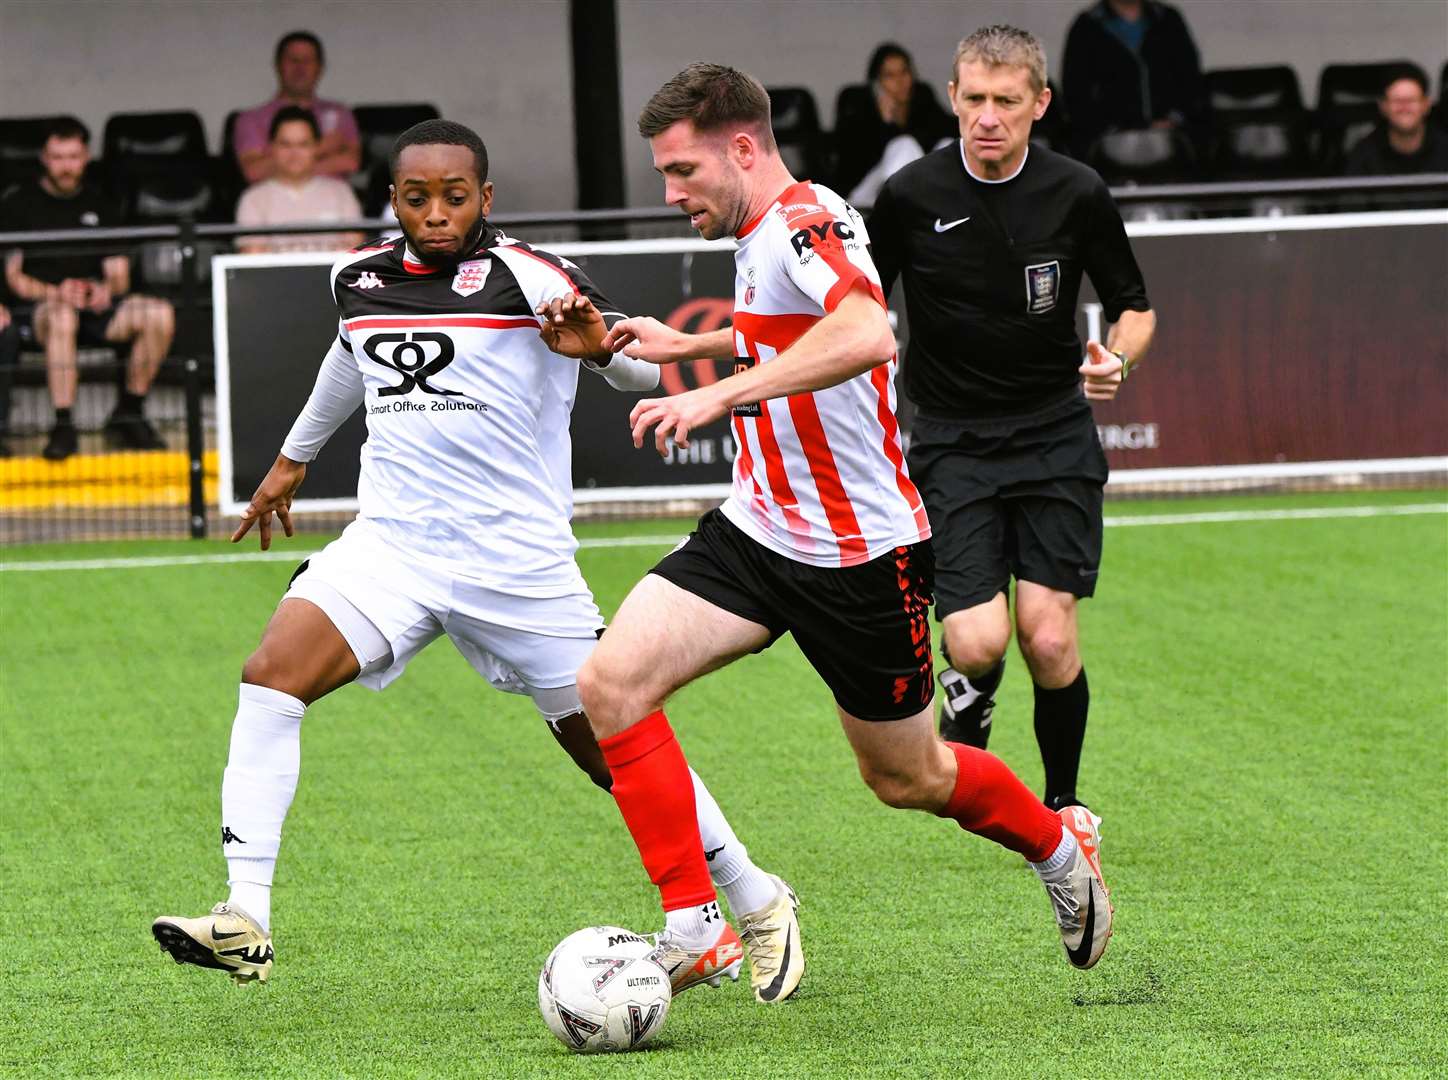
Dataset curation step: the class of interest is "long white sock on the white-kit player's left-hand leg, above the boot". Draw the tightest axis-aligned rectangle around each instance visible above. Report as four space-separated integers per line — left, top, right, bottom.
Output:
222 683 307 932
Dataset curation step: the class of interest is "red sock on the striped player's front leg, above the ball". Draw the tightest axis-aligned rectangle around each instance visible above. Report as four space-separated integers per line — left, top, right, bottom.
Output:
598 712 714 911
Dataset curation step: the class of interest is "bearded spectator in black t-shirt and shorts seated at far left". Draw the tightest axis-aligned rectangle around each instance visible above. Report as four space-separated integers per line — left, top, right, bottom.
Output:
0 119 175 460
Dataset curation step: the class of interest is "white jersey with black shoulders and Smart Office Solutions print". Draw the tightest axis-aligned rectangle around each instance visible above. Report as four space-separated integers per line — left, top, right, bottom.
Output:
282 229 621 596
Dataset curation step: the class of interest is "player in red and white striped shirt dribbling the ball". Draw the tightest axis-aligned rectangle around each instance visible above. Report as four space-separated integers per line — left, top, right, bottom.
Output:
578 64 1112 996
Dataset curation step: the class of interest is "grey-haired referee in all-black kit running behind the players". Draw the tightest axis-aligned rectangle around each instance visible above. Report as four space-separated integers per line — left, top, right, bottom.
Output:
869 26 1156 809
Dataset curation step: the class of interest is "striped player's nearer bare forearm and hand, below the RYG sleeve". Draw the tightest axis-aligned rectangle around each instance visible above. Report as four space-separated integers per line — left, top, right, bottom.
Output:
628 282 895 456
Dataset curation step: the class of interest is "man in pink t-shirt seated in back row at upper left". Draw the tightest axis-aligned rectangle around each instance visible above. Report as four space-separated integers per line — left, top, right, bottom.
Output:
233 30 362 184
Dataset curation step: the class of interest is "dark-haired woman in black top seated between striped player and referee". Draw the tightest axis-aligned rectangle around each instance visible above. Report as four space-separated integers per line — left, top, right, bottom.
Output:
834 42 956 206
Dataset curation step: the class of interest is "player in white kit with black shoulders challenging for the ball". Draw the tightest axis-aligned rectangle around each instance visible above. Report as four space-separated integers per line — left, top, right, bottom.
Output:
152 120 798 1000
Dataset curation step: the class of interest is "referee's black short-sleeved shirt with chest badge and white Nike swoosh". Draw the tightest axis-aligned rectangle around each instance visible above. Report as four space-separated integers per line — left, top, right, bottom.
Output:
869 142 1151 421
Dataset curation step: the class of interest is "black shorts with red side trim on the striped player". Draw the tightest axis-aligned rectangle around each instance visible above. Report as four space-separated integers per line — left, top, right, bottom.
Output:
652 510 935 721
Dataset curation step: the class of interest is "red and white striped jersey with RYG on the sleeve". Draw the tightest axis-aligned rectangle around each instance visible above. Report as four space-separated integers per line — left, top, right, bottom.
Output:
723 182 930 566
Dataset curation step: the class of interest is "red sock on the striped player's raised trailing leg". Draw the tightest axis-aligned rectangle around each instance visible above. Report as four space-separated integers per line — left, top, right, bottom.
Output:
940 743 1061 863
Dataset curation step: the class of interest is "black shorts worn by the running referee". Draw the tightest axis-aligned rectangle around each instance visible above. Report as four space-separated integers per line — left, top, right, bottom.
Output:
909 402 1106 618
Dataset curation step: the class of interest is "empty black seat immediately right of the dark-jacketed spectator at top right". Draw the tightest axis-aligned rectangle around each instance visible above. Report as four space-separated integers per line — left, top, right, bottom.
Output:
1206 65 1312 180
